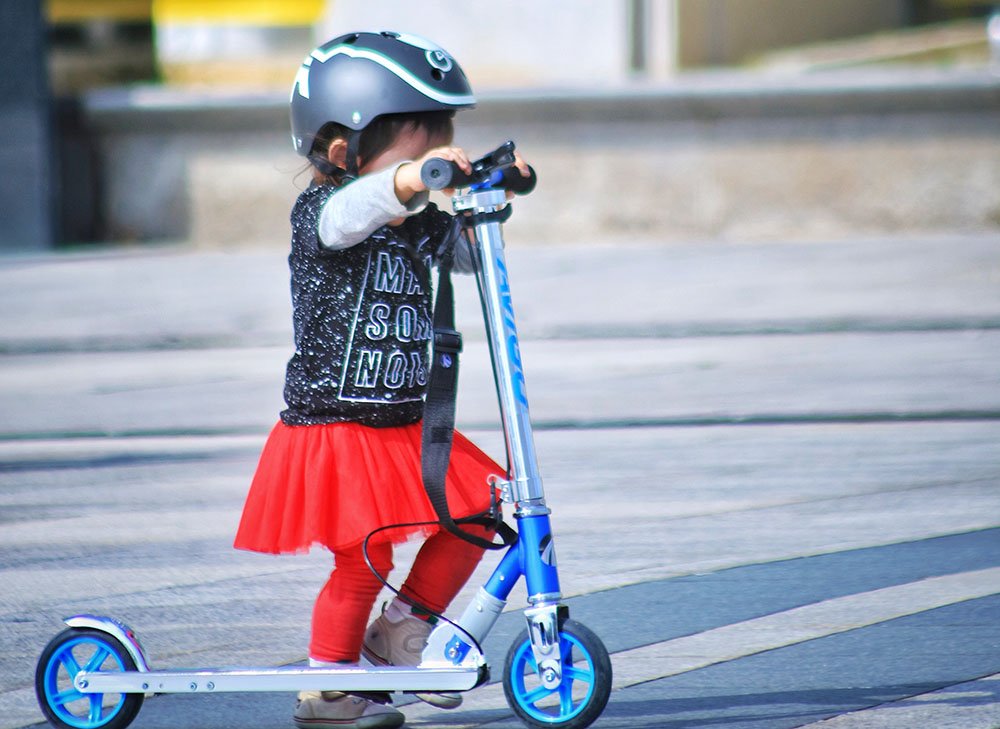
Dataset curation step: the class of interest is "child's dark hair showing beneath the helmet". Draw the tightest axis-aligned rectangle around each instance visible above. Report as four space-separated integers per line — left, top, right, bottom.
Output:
309 111 455 185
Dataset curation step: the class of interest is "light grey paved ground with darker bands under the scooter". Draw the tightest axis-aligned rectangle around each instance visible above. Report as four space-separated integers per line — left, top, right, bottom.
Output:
0 229 1000 729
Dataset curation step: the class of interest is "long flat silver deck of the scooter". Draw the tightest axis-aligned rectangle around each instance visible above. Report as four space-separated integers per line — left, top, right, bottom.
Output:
74 665 489 694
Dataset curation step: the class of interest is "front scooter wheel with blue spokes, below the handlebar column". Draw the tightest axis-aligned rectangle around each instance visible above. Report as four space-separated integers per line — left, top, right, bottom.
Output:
503 620 611 729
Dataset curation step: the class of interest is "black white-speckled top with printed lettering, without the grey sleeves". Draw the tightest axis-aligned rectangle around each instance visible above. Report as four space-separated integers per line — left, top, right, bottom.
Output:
281 186 451 427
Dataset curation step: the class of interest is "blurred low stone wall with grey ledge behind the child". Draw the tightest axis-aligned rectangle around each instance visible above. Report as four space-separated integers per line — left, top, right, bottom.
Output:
78 71 1000 247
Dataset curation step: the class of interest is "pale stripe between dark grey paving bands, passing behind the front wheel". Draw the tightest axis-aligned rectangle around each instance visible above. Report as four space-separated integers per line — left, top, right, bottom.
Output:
405 567 1000 728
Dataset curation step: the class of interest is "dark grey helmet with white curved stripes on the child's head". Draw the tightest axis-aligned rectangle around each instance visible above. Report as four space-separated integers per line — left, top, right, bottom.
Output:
291 31 476 155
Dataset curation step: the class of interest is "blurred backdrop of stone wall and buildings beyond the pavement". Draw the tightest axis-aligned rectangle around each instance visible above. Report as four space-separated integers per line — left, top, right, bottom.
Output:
0 0 1000 251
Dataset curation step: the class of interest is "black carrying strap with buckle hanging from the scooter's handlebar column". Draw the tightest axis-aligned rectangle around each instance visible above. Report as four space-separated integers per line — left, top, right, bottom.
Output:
421 218 516 549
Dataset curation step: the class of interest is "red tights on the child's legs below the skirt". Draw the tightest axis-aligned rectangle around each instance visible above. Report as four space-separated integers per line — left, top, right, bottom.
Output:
309 524 491 663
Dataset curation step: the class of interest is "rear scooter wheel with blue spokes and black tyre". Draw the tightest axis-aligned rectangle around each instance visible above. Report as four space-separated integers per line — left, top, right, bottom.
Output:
35 628 144 729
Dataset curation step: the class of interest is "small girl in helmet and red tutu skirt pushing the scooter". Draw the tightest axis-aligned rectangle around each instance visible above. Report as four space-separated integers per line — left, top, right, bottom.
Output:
235 33 527 729
